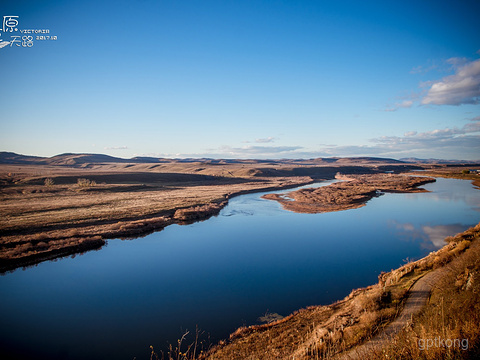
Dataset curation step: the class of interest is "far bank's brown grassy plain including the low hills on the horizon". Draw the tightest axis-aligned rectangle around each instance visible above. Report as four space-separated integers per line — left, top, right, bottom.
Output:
0 158 428 272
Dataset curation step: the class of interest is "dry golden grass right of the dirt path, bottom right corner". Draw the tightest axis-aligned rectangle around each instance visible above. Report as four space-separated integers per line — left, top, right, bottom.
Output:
370 229 480 360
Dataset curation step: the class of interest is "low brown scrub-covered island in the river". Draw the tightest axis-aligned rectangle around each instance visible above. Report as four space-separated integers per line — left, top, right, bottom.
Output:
262 174 435 213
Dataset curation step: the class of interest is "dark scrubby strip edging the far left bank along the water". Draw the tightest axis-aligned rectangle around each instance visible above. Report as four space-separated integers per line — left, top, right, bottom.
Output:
0 178 316 274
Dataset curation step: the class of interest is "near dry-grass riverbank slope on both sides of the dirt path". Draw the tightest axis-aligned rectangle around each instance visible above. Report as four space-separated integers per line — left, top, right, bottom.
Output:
205 223 480 360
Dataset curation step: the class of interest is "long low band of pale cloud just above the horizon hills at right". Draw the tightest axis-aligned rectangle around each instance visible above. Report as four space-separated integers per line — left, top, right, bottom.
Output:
137 118 480 160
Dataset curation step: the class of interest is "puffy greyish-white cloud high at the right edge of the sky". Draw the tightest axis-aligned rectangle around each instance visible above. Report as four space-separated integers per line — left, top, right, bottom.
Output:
421 58 480 105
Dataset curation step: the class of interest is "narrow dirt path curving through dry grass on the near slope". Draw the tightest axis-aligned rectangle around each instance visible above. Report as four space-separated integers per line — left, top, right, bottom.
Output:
335 268 445 360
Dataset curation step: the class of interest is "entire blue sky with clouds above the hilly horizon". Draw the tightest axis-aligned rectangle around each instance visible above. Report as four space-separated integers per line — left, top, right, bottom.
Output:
0 0 480 160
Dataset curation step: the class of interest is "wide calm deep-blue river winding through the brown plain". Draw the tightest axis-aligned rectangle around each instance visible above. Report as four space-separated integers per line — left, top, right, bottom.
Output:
0 179 480 360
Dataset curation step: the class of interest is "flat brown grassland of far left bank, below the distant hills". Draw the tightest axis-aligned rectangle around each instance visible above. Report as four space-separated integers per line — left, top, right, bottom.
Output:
0 167 312 271
